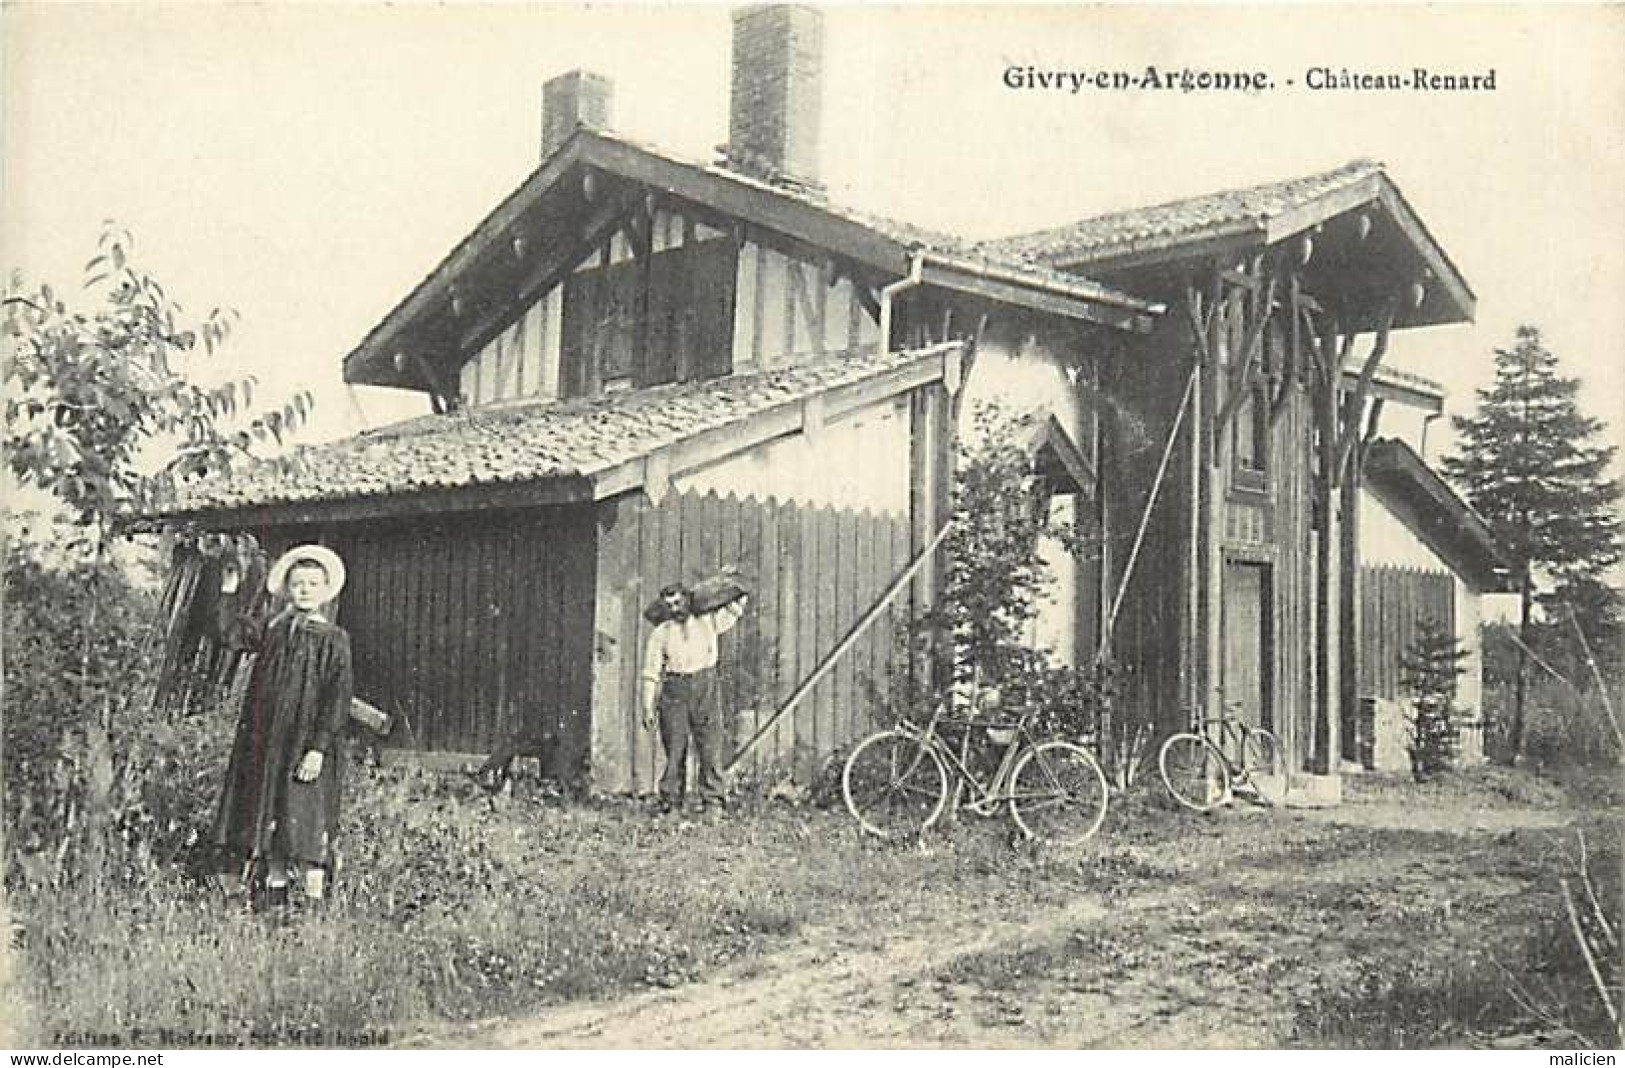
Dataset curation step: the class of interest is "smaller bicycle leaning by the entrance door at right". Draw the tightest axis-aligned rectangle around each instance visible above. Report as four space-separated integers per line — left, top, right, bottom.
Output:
1157 702 1285 813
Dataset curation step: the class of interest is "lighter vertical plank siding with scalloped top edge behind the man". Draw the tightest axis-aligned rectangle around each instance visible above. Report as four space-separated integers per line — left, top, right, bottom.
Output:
593 493 910 793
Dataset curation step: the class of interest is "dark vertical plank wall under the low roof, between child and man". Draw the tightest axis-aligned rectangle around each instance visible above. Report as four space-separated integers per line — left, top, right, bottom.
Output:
325 507 593 775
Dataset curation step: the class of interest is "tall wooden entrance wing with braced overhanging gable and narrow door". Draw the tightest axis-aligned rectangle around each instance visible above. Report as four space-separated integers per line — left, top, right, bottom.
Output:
990 161 1474 800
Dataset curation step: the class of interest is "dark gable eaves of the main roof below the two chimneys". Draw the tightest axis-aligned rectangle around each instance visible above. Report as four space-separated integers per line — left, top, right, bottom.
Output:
345 128 1160 389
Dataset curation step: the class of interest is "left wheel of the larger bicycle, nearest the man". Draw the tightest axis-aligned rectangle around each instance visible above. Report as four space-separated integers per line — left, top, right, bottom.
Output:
840 730 947 839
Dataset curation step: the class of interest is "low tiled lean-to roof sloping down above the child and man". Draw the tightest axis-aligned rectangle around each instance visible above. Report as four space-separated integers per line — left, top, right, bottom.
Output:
153 346 943 519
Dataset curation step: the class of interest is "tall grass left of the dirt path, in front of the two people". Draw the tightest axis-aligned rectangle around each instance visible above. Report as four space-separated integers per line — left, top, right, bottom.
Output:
6 757 1105 1045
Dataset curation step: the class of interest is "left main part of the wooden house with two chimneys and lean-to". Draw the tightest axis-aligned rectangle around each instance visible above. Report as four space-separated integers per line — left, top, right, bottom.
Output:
152 8 1157 790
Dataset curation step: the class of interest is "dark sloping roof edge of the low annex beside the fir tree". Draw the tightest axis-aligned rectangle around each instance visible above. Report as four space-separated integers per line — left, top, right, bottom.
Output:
1362 437 1511 593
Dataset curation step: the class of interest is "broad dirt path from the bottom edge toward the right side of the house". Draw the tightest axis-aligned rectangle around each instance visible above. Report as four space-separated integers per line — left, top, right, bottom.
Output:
403 786 1573 1048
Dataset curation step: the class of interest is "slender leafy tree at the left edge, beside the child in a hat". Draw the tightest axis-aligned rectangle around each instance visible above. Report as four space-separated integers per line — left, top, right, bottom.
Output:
0 224 312 890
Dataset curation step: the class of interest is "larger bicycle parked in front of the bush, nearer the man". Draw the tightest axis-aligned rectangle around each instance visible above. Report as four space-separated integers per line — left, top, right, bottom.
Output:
840 705 1107 845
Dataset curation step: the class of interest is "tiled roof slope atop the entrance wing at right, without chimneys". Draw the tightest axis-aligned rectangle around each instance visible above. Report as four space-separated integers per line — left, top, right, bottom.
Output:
983 159 1383 263
